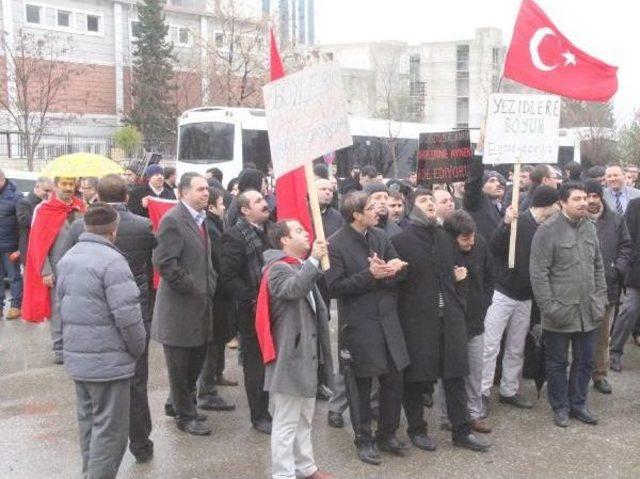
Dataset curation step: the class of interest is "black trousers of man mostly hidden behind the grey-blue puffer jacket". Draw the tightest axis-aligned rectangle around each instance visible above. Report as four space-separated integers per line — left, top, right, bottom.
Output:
129 328 153 456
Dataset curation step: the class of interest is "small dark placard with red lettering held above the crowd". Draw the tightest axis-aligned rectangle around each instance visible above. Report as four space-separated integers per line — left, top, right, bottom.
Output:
417 130 473 183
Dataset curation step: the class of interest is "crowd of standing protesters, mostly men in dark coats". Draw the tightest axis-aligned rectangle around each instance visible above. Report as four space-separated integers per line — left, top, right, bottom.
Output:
7 157 640 479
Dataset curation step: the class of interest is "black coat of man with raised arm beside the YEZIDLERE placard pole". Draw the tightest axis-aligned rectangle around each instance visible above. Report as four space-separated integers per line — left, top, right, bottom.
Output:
463 156 505 246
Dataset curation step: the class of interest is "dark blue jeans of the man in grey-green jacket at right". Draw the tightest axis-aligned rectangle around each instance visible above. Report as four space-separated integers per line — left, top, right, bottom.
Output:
544 329 598 412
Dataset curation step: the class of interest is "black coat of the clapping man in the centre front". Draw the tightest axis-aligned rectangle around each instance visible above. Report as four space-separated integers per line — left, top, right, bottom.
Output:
324 225 409 377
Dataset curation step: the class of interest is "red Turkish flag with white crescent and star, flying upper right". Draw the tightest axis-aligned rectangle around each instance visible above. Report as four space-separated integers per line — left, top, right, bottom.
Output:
504 0 618 102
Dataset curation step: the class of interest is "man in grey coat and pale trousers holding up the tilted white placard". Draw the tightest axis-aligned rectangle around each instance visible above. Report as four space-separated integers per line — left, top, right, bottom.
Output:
257 220 333 479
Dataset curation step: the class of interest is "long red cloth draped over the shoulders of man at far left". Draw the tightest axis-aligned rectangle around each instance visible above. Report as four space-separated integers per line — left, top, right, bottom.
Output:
22 196 86 323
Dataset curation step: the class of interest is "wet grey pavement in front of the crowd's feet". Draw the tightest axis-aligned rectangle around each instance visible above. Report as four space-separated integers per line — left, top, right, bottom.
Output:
0 320 640 479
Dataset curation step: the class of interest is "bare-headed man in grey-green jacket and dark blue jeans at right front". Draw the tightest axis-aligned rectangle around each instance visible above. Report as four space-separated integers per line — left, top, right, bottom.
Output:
530 182 607 427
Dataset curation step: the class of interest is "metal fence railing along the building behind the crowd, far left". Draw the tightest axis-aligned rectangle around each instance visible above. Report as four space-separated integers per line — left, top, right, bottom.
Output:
0 131 176 162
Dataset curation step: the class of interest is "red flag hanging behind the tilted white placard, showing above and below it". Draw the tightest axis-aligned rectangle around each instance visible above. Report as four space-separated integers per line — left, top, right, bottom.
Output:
271 30 314 241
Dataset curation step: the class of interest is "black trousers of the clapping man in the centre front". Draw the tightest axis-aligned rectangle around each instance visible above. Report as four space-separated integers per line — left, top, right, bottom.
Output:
345 361 402 447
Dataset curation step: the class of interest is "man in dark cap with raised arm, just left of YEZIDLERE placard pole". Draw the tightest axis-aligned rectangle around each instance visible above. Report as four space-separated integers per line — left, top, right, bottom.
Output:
462 156 506 241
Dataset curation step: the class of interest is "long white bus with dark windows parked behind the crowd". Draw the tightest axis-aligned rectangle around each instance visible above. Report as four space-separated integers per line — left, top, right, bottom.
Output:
176 107 580 184
